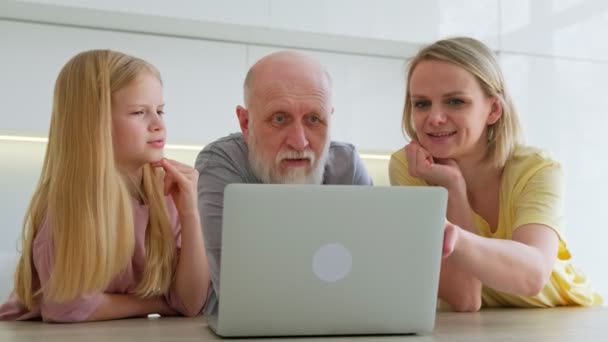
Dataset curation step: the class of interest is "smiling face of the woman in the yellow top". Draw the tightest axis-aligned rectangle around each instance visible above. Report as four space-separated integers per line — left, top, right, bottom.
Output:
408 60 502 160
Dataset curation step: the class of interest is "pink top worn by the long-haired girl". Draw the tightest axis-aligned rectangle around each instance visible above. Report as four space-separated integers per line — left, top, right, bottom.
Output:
0 197 185 322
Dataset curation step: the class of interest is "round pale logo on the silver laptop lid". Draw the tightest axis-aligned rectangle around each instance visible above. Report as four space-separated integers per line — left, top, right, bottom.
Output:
312 243 353 283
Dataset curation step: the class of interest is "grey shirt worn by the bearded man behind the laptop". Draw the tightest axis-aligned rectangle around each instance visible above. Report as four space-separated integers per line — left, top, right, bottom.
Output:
196 133 372 315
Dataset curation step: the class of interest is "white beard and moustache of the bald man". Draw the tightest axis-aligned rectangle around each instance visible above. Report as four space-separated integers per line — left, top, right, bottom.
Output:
247 131 330 184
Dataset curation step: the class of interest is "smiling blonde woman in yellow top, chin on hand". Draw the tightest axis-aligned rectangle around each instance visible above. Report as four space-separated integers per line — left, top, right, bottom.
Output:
389 38 602 311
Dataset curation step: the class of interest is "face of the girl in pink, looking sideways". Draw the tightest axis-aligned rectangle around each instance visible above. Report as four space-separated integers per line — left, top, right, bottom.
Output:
112 73 166 175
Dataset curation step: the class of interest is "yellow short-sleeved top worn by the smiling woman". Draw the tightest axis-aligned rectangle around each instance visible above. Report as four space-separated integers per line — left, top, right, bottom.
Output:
389 146 603 307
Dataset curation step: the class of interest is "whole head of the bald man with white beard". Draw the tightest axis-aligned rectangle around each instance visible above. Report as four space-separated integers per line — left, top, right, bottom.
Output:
236 51 333 184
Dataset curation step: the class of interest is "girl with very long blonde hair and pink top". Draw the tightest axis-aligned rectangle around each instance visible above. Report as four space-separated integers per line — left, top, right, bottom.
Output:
0 50 209 322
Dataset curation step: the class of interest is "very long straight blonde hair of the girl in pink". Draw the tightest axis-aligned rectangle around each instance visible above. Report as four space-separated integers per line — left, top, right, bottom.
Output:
15 50 175 309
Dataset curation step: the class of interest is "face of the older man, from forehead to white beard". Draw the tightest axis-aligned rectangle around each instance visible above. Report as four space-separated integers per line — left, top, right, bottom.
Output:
244 79 333 184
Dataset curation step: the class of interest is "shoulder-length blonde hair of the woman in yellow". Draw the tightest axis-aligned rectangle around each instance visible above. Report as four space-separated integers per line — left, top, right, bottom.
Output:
402 37 523 167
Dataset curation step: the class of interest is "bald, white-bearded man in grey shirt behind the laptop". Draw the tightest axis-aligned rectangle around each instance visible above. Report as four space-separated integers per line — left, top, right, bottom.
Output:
196 51 372 315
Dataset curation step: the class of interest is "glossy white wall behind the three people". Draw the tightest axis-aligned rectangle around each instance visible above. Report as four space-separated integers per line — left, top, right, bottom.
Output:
0 0 608 296
